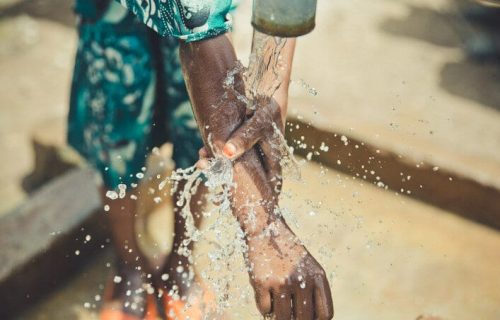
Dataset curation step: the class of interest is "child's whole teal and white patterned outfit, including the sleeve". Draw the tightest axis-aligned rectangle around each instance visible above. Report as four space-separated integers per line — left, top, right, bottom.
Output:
68 0 236 189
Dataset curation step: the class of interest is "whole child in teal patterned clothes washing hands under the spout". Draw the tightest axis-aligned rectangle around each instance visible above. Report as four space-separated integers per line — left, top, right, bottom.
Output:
69 0 333 320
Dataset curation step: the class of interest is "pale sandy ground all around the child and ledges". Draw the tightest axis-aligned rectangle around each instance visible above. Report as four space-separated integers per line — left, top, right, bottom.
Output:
0 0 500 320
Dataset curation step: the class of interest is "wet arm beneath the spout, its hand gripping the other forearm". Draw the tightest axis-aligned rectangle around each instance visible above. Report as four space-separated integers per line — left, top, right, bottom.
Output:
197 31 296 185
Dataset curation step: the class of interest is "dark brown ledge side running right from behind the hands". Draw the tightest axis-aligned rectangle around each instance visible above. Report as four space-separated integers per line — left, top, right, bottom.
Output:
286 118 500 230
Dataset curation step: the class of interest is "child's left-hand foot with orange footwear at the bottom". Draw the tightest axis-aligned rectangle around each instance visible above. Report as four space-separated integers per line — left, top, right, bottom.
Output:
100 267 159 320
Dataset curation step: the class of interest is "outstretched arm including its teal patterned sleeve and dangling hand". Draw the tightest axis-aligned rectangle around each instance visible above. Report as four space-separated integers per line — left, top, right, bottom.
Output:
113 0 333 320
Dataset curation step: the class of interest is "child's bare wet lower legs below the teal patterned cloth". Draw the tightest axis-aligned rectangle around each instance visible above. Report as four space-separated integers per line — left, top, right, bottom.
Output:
101 182 206 318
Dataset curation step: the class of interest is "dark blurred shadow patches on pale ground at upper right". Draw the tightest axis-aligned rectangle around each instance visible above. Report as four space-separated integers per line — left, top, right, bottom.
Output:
380 2 500 111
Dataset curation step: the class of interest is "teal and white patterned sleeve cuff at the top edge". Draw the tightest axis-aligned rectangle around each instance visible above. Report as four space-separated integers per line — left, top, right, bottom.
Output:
116 0 232 42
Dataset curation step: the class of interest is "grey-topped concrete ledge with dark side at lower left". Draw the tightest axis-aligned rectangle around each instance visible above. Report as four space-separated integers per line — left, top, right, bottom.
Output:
0 169 106 319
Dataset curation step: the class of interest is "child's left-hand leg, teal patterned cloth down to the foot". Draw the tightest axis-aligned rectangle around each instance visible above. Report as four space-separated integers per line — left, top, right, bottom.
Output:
68 0 160 318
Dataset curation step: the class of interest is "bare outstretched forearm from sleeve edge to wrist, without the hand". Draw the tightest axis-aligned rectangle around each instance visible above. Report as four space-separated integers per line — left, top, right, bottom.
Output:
180 36 273 234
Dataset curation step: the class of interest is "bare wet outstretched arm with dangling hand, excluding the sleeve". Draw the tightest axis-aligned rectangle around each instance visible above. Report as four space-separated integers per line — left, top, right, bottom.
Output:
180 36 333 320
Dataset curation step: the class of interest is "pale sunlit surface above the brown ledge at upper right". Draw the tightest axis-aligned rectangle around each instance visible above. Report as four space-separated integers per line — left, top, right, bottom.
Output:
291 0 500 189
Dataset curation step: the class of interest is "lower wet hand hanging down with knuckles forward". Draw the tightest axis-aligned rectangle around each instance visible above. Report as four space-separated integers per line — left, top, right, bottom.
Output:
247 220 333 320
